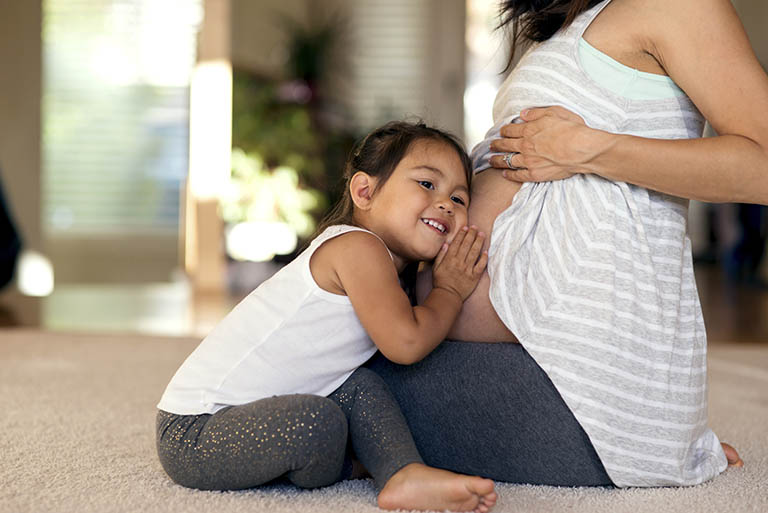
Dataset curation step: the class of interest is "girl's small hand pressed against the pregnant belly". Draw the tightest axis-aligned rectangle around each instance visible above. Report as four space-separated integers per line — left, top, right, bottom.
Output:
432 226 488 302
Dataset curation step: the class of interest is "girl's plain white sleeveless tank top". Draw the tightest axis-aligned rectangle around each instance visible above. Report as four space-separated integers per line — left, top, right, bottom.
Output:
157 225 383 415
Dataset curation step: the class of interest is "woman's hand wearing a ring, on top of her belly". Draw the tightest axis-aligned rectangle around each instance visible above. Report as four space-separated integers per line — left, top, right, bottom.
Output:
491 106 601 182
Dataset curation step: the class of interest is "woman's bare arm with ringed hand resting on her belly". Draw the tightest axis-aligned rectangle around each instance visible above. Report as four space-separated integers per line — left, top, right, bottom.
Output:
493 0 768 204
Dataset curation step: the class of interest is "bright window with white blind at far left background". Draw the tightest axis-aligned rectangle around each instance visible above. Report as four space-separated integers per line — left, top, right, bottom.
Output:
43 0 202 237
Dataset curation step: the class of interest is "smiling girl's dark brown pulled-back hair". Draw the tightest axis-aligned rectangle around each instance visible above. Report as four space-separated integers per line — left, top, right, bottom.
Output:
316 121 472 235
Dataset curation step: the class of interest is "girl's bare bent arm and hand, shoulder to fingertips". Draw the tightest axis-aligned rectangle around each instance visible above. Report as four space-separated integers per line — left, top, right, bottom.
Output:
324 228 487 364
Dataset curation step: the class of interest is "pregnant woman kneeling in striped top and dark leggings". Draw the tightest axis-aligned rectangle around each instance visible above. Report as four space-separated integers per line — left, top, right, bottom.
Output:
372 0 768 486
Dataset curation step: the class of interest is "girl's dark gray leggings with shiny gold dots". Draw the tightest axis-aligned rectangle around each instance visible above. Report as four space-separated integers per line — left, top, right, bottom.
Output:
157 368 422 490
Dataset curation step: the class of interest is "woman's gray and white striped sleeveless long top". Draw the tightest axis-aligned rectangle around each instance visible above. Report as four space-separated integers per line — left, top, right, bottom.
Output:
473 0 727 486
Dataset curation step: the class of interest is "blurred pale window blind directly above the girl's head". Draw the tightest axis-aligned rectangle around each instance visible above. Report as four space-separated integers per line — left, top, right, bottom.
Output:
336 0 465 139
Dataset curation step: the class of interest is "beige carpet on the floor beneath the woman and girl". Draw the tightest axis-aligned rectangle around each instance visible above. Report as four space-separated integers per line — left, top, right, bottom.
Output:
0 330 768 513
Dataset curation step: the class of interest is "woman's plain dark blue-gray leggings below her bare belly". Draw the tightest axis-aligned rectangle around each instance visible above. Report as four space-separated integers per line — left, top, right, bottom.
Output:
368 341 612 486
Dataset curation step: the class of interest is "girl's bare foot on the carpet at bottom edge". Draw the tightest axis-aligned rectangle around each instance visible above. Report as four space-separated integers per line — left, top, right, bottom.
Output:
379 463 497 513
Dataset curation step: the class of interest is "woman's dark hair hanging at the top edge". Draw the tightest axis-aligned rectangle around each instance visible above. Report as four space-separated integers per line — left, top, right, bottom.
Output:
496 0 602 71
